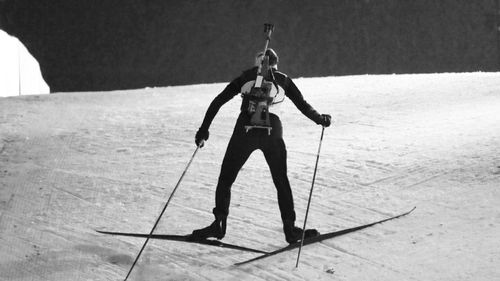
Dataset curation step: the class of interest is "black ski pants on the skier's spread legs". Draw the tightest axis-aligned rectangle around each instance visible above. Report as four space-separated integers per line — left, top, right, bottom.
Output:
213 132 295 223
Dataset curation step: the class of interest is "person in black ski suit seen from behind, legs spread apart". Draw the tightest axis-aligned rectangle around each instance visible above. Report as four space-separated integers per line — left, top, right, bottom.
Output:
191 48 331 243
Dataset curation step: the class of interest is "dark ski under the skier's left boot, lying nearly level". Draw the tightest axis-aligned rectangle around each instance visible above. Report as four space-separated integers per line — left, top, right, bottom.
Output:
96 230 267 254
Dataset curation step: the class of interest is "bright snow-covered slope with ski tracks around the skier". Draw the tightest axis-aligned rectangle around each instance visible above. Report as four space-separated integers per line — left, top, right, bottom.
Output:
0 73 500 281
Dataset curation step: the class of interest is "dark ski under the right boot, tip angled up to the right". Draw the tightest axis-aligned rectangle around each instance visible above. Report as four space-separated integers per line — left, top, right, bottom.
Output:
234 207 416 266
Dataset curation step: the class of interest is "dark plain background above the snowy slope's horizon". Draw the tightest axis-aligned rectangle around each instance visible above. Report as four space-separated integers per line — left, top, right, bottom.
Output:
0 0 500 92
